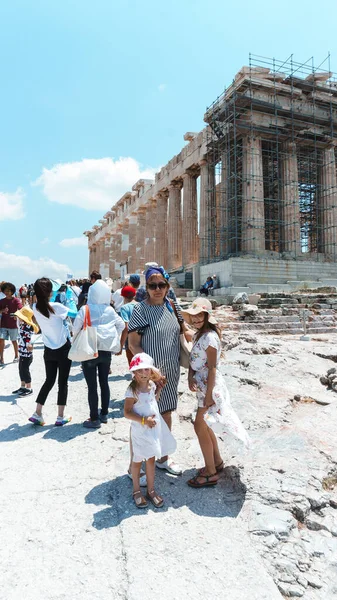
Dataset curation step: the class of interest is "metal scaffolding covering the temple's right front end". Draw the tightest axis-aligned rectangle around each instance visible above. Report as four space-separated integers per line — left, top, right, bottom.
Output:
200 54 337 264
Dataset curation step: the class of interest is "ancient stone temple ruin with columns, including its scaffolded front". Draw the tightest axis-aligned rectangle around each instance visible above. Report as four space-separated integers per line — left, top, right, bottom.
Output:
85 55 337 296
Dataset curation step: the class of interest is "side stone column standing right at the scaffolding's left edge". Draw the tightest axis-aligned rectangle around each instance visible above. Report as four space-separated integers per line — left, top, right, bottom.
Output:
199 160 216 263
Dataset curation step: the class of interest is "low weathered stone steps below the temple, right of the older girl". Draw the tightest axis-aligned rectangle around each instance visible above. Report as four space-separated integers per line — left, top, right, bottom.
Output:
219 293 337 335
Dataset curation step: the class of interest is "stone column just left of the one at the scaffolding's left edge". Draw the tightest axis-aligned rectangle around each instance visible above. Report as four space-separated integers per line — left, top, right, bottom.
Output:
182 172 199 265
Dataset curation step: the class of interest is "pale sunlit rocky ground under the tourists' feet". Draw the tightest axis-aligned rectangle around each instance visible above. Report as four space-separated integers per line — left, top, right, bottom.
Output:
0 332 337 600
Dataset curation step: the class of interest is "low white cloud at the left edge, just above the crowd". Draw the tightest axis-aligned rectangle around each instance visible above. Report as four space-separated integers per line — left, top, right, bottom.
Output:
0 252 76 285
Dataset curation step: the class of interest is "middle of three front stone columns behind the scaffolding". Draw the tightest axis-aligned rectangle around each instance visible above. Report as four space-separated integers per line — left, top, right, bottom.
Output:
281 141 301 256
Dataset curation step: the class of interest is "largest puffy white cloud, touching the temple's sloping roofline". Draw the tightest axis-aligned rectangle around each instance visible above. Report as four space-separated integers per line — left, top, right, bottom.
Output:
33 157 156 210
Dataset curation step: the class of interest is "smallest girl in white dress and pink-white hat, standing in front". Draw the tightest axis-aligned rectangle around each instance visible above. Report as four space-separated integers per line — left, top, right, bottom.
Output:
124 352 177 508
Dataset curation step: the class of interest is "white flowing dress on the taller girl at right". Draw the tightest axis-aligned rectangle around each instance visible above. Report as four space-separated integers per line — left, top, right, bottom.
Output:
190 331 251 447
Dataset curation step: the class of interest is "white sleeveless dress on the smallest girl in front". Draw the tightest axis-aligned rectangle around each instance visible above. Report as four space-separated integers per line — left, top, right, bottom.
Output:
125 381 177 462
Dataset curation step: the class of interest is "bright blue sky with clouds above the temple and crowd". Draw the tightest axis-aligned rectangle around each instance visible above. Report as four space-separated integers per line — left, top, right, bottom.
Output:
0 0 337 284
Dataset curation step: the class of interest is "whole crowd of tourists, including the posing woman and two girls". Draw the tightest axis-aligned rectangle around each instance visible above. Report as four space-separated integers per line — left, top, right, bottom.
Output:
0 263 249 508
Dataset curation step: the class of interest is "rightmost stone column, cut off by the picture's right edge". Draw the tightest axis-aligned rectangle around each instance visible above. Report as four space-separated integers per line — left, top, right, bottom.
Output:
319 146 337 256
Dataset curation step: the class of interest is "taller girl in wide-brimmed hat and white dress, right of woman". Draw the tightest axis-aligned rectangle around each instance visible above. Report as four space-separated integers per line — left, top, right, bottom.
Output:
181 298 250 488
